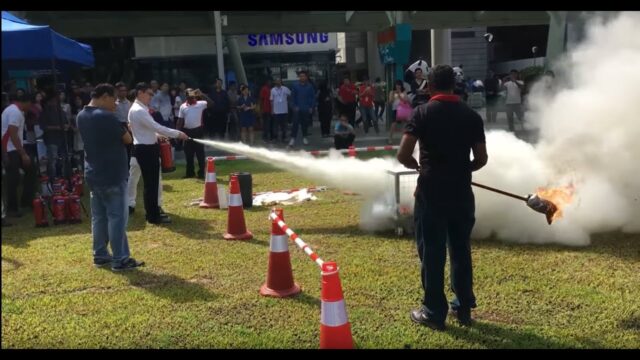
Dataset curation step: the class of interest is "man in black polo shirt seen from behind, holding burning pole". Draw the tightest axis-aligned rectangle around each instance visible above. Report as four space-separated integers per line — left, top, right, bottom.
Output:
398 65 487 330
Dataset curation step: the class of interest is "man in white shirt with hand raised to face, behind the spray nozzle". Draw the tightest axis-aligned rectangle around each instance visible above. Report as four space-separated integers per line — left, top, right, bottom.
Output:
176 89 212 179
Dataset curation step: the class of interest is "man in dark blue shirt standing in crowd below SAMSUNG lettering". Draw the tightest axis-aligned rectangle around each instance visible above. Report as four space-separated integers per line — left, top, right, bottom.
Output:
288 70 316 148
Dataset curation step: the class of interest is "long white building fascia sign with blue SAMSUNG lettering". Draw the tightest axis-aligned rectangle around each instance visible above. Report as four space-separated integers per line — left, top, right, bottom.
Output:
134 33 338 58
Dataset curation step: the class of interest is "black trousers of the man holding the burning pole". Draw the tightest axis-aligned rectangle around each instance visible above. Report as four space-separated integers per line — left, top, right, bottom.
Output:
414 180 476 322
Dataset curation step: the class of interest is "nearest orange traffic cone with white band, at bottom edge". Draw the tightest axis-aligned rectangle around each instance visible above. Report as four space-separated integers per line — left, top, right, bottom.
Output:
320 262 353 349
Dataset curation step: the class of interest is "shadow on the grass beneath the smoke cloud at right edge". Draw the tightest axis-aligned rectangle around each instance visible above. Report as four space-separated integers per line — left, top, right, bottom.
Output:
471 232 640 262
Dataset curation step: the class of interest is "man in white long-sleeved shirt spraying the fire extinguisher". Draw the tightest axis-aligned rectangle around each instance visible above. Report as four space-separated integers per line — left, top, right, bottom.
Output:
129 83 189 224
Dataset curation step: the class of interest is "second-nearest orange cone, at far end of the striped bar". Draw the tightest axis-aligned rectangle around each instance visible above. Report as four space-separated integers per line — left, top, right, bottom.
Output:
260 209 300 297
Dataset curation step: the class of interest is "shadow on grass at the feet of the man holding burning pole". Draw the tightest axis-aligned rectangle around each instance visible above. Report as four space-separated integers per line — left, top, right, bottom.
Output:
446 321 600 349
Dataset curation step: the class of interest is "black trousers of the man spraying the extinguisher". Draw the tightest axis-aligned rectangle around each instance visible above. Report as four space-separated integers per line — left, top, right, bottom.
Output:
135 144 160 222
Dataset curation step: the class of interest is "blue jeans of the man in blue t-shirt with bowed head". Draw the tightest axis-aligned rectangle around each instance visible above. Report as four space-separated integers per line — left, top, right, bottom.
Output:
89 181 130 266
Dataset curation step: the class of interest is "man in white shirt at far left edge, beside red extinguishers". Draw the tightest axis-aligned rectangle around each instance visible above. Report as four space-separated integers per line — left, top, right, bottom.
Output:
2 94 36 217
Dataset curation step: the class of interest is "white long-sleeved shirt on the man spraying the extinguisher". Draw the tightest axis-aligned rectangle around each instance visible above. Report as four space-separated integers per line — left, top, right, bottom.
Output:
129 100 180 145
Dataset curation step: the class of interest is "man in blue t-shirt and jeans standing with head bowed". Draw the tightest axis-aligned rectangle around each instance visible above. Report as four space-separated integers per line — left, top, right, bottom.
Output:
77 84 144 271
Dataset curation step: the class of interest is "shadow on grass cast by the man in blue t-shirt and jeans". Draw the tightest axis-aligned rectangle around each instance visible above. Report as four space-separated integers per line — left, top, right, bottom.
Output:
115 270 220 303
